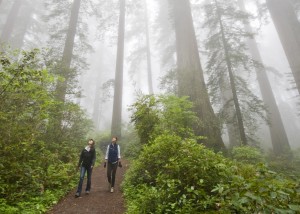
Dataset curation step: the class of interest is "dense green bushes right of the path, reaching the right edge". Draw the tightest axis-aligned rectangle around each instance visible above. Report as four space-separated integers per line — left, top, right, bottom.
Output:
122 134 300 213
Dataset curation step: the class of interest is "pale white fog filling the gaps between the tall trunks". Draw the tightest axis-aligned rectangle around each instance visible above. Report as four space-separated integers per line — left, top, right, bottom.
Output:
0 0 300 149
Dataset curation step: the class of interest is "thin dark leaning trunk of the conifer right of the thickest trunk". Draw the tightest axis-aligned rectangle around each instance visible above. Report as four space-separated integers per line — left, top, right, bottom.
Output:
215 0 247 145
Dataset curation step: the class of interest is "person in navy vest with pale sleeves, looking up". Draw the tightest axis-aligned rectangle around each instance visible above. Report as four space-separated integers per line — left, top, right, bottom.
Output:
104 137 122 192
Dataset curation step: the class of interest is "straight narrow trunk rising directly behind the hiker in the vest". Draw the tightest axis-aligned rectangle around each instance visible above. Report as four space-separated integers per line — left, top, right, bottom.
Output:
111 0 125 137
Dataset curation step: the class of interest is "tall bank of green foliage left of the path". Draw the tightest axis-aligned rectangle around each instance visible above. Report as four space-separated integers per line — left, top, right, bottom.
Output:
0 50 91 213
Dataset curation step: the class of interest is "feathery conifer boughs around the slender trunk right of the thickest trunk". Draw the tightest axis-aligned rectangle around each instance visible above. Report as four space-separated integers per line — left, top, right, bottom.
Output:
204 0 267 143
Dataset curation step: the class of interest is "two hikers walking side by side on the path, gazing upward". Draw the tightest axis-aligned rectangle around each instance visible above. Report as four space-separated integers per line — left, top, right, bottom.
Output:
75 137 122 198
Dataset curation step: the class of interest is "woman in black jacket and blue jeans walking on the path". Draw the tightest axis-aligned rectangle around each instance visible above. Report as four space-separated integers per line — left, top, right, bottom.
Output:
75 139 96 198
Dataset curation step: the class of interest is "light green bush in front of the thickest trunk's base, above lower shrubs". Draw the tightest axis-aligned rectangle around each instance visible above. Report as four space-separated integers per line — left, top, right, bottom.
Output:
130 95 199 144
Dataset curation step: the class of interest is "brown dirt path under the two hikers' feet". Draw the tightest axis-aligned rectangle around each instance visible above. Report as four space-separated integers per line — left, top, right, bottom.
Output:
47 160 128 214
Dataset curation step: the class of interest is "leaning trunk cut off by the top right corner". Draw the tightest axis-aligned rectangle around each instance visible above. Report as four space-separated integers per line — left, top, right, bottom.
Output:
267 0 300 94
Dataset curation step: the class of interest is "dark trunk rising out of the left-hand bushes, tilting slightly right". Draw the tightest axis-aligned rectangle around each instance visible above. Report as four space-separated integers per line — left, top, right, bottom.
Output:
56 0 81 102
